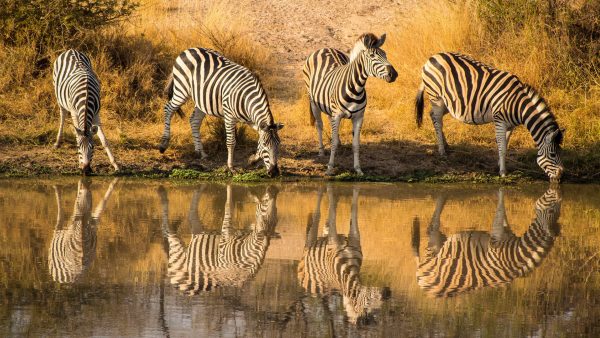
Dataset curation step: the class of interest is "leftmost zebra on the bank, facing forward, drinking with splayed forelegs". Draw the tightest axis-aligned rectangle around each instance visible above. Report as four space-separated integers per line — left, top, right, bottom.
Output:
53 49 119 175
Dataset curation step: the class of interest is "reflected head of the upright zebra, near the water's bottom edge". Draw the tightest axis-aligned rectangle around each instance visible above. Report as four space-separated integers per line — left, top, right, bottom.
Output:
344 285 391 324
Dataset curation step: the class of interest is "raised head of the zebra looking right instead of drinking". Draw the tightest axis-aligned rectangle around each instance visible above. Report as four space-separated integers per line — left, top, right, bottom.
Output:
350 33 398 82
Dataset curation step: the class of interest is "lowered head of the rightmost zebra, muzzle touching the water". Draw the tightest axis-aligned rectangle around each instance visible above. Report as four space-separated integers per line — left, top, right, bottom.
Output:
537 129 564 183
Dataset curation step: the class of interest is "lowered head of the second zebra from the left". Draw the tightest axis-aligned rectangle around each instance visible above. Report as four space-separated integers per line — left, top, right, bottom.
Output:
250 123 283 177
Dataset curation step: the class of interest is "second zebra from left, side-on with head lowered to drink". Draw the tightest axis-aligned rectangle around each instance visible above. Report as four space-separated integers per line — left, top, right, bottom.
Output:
159 48 283 176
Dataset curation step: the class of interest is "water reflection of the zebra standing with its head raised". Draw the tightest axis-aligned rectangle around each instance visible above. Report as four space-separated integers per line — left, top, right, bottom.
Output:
298 187 389 324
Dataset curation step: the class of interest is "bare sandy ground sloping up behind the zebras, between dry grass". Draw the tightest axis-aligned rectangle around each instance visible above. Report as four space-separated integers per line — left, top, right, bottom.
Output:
242 0 413 99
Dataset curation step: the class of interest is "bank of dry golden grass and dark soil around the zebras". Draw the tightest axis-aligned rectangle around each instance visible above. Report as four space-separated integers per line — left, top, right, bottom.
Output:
0 0 600 182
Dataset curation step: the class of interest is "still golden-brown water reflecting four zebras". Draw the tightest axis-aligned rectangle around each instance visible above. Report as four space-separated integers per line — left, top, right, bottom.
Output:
0 178 600 337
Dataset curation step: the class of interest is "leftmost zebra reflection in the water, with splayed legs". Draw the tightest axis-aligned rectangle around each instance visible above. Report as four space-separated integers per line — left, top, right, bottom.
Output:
48 179 117 283
